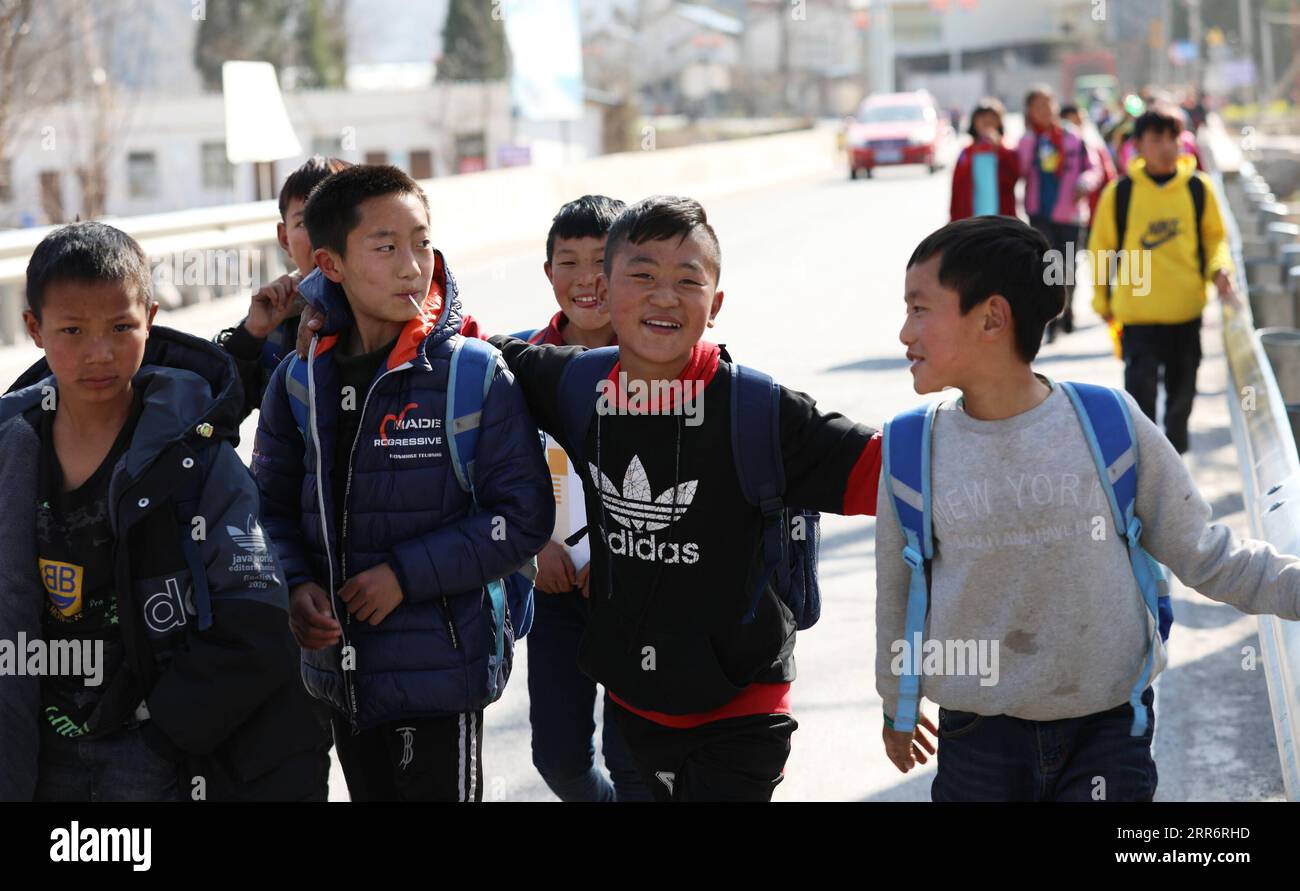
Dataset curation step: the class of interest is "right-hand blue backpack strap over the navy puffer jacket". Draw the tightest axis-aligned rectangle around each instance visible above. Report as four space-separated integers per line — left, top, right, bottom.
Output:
443 336 506 661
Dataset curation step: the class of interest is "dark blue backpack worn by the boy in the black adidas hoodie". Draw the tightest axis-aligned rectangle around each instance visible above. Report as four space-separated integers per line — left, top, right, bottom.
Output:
559 346 822 631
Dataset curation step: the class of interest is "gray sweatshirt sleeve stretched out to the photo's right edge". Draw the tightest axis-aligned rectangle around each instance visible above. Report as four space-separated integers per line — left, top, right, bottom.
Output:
1128 393 1300 619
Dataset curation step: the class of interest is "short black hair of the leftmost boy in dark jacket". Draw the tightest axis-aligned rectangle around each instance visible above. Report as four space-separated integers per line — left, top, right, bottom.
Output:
26 220 153 321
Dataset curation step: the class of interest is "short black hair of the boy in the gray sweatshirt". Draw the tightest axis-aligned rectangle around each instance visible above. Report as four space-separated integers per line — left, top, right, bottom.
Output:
907 216 1065 363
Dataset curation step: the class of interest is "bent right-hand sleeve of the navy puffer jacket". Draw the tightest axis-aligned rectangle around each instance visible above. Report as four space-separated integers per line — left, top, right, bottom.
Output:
389 367 555 602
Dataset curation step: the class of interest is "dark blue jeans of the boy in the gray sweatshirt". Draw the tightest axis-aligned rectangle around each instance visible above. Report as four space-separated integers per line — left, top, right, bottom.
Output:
930 687 1158 801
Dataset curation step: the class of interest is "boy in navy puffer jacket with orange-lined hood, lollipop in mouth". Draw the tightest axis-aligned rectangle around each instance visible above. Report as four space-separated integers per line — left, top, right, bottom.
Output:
252 165 555 801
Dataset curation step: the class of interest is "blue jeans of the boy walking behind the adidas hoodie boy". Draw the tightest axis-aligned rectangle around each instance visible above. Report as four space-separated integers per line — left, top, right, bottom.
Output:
527 591 651 801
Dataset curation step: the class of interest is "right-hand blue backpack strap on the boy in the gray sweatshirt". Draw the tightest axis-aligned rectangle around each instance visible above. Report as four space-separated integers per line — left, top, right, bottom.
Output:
1060 382 1167 736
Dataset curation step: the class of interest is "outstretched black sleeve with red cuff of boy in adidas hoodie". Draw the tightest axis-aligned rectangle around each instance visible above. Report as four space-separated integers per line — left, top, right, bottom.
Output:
781 386 881 516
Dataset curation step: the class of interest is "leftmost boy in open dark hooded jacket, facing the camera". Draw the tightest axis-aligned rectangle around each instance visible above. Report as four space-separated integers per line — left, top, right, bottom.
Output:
0 222 324 801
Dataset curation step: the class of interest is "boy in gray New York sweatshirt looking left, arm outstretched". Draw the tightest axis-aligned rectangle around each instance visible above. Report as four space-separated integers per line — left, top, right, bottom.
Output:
876 217 1300 801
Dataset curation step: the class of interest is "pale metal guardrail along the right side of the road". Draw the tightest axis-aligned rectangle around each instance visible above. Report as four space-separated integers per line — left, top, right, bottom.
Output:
1210 144 1300 801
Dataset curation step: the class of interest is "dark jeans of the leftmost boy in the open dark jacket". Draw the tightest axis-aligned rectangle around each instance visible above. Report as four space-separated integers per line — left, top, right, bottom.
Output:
35 727 190 801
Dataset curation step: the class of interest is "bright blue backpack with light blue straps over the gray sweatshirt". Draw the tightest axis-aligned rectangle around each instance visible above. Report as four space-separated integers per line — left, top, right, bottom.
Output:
881 382 1174 736
